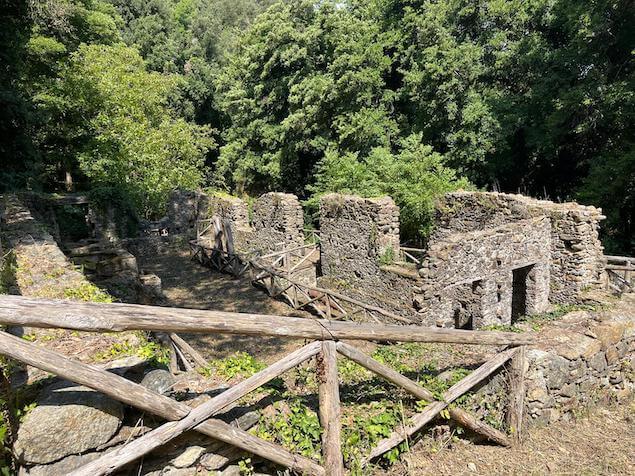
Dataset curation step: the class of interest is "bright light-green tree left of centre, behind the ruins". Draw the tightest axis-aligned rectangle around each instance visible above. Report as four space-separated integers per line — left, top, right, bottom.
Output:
48 44 213 217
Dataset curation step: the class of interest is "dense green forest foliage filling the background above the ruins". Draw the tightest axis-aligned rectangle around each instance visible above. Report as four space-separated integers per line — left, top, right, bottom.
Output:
0 0 635 249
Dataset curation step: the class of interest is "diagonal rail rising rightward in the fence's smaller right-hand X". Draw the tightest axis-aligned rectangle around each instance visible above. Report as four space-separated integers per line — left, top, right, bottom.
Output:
366 349 515 461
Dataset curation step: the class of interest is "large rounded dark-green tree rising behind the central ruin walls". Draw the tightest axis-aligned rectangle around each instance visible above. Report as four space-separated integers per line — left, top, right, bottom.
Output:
216 2 398 194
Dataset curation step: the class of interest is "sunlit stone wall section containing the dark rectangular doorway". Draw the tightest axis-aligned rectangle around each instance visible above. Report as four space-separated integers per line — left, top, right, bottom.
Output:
414 216 551 328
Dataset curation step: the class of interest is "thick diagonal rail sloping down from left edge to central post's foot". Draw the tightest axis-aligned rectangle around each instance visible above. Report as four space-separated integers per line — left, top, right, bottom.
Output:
0 332 324 476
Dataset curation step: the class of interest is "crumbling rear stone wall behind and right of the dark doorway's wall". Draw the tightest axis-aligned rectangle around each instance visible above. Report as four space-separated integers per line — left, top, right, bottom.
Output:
438 192 605 303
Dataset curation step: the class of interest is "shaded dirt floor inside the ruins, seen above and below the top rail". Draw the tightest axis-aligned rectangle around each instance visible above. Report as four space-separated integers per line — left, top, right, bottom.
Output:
140 251 307 362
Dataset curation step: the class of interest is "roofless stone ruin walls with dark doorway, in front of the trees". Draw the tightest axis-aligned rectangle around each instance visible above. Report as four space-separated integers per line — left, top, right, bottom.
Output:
178 188 604 329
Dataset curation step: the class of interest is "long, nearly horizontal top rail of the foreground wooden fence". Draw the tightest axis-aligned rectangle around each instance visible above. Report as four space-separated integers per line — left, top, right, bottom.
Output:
0 295 533 346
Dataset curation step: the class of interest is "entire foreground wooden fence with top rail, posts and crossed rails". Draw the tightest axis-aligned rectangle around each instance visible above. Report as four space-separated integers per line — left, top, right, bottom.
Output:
0 295 532 476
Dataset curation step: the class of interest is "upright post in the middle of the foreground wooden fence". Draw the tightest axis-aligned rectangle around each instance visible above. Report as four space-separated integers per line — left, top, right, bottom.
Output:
317 341 344 476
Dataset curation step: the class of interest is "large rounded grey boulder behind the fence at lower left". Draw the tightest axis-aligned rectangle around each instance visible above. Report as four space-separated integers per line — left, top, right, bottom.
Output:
13 381 123 464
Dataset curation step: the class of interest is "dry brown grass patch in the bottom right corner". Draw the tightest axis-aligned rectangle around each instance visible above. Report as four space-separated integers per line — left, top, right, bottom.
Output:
383 401 635 476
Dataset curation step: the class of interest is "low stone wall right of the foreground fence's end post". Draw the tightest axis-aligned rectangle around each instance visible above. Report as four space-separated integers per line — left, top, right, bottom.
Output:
526 297 635 423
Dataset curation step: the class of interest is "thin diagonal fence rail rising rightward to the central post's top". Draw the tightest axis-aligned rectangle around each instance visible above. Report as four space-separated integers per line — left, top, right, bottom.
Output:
71 342 321 476
